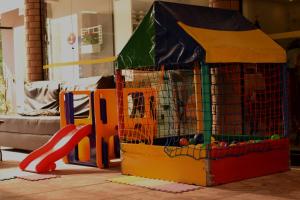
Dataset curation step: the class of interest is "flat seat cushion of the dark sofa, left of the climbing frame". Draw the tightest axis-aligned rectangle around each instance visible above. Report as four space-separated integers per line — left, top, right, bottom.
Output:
0 115 60 135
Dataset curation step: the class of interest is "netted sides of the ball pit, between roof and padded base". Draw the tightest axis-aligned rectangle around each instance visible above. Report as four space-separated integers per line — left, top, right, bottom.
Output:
119 64 285 159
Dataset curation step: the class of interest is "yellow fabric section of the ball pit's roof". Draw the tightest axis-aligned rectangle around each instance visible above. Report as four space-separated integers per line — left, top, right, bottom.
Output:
178 22 286 63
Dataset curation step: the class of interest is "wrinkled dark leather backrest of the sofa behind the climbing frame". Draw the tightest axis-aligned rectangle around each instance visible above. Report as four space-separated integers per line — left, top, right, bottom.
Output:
18 76 115 117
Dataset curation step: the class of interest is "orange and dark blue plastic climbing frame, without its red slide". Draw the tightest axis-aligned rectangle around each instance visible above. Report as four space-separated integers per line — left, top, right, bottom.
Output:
60 89 120 168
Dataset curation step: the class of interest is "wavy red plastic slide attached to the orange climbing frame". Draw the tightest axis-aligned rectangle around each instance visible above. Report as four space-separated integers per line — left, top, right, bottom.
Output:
19 124 92 173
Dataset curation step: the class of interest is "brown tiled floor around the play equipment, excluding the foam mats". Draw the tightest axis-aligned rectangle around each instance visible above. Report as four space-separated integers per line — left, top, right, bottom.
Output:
0 151 300 200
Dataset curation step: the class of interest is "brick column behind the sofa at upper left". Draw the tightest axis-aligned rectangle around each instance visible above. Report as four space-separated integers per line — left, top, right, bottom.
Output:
24 0 45 81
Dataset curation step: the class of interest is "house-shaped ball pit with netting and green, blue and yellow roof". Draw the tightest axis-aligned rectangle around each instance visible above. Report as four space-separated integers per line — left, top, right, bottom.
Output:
116 1 289 186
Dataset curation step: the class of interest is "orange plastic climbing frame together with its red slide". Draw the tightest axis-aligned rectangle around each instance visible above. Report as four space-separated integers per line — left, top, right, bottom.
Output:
19 89 120 173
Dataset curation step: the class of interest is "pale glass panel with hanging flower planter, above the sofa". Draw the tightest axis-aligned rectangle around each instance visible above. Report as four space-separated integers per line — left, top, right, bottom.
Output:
47 0 114 81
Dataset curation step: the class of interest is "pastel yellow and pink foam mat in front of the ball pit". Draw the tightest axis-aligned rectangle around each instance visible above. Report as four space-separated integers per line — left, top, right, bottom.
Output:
108 175 201 193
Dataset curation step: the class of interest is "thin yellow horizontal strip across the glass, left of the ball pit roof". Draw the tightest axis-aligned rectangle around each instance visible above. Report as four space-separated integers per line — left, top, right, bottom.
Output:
43 56 116 69
